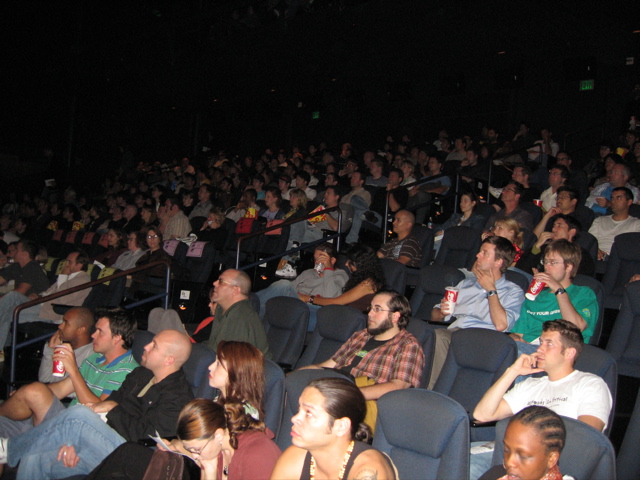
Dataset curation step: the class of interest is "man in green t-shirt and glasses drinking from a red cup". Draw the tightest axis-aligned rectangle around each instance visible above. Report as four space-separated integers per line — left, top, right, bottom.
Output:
511 239 599 354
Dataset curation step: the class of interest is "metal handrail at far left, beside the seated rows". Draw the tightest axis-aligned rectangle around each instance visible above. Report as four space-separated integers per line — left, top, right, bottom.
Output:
9 260 171 388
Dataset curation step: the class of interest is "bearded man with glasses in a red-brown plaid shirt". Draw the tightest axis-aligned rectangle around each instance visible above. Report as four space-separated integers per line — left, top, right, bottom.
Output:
304 290 424 400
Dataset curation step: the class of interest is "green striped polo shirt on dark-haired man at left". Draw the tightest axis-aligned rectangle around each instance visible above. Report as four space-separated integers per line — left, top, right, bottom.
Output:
70 350 138 406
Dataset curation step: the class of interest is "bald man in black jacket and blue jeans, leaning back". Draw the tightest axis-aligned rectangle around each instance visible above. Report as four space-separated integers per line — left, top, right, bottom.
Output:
0 330 193 479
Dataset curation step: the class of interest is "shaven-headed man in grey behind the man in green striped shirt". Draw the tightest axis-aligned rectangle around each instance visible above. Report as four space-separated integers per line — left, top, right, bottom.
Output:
38 307 95 383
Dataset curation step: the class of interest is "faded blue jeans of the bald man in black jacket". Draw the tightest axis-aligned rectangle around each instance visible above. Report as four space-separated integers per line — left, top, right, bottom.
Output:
7 405 126 480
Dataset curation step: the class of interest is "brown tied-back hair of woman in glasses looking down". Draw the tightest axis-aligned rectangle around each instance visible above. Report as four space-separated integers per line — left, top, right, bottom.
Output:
177 398 265 449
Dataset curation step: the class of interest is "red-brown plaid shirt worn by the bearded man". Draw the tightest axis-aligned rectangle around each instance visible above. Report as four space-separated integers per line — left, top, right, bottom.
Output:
332 329 424 388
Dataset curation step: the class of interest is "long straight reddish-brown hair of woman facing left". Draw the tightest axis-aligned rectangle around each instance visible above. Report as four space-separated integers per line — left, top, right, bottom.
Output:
216 341 264 429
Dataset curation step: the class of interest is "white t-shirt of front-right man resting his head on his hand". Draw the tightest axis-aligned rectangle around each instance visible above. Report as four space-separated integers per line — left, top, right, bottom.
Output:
503 370 612 428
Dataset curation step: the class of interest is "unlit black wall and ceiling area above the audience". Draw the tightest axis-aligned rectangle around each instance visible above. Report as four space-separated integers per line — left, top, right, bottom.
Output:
0 0 640 176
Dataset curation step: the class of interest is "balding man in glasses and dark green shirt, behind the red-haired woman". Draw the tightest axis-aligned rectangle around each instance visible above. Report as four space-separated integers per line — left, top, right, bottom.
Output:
207 269 271 358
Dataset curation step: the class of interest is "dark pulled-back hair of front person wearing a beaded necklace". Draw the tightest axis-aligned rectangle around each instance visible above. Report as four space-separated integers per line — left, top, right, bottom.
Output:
307 378 371 442
